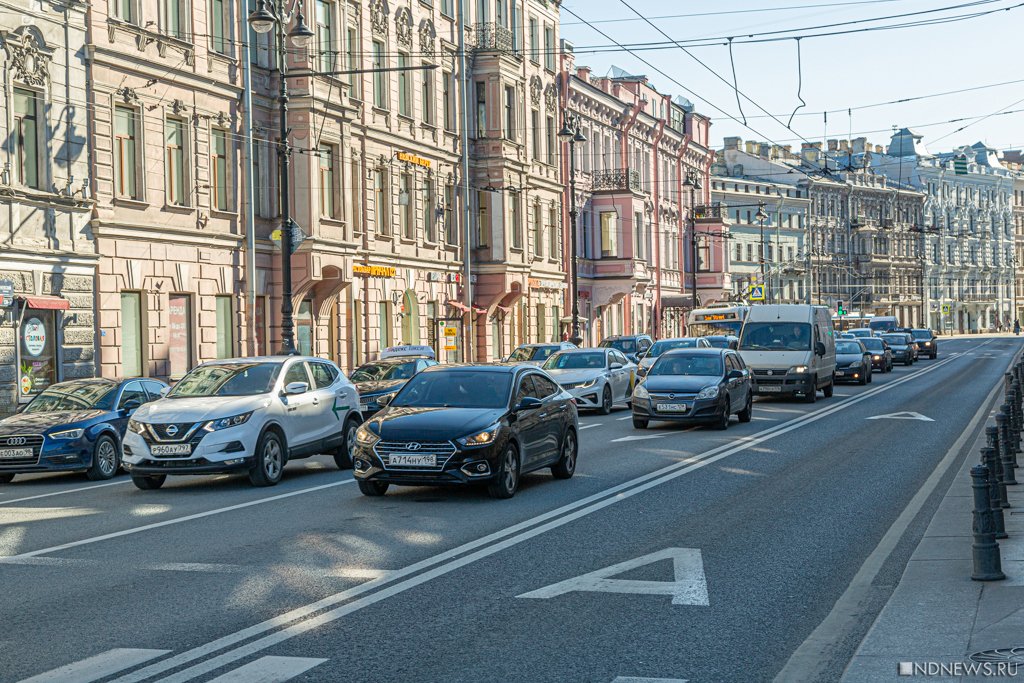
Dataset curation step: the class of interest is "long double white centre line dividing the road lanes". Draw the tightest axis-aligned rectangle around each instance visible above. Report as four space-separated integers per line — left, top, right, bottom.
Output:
113 348 974 683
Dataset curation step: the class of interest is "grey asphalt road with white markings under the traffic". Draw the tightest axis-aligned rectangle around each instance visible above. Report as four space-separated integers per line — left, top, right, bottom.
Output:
0 337 1020 683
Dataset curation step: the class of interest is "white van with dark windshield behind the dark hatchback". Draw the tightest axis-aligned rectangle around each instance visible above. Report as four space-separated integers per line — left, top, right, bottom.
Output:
739 304 836 402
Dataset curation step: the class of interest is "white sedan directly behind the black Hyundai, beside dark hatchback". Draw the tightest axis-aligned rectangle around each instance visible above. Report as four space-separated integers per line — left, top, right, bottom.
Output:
542 347 637 415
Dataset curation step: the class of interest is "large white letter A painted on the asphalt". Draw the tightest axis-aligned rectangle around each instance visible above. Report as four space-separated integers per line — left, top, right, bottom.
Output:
516 548 710 606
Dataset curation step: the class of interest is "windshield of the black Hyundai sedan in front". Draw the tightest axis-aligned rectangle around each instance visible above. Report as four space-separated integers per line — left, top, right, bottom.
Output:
389 370 512 409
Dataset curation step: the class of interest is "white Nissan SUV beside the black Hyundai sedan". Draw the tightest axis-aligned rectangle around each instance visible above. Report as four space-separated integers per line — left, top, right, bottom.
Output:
123 356 362 488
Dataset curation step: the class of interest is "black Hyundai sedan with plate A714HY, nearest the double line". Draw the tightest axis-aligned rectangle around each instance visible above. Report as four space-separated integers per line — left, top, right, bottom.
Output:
354 364 580 499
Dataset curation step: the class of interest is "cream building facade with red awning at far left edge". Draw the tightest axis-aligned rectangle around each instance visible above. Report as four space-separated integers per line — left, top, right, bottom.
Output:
0 0 97 416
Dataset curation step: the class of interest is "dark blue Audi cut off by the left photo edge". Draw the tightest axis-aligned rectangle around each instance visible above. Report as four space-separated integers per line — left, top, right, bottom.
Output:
0 378 167 483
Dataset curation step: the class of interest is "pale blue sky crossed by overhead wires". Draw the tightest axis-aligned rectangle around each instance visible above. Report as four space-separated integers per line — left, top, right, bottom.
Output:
560 0 1024 153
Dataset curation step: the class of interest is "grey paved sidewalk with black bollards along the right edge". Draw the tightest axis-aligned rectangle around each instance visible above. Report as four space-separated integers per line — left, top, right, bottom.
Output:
842 420 1024 683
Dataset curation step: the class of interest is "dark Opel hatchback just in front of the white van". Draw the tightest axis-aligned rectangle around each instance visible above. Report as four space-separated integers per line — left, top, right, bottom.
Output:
633 348 754 429
